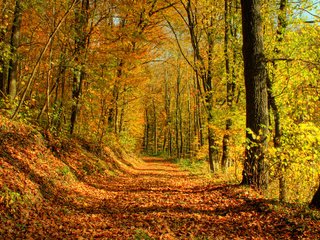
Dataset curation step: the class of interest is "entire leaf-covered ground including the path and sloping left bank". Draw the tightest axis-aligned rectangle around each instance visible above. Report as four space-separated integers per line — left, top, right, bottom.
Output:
0 117 320 240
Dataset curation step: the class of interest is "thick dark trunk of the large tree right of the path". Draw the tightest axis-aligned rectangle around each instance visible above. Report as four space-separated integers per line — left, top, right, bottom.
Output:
241 0 269 189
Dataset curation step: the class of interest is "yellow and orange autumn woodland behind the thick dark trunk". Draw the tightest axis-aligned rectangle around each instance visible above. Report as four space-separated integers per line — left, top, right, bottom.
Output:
0 0 320 203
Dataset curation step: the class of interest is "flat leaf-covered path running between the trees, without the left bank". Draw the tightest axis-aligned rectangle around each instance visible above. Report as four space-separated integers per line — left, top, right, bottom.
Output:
3 158 320 239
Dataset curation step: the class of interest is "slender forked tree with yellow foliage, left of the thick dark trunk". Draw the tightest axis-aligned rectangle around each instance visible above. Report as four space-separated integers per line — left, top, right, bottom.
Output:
167 0 222 172
